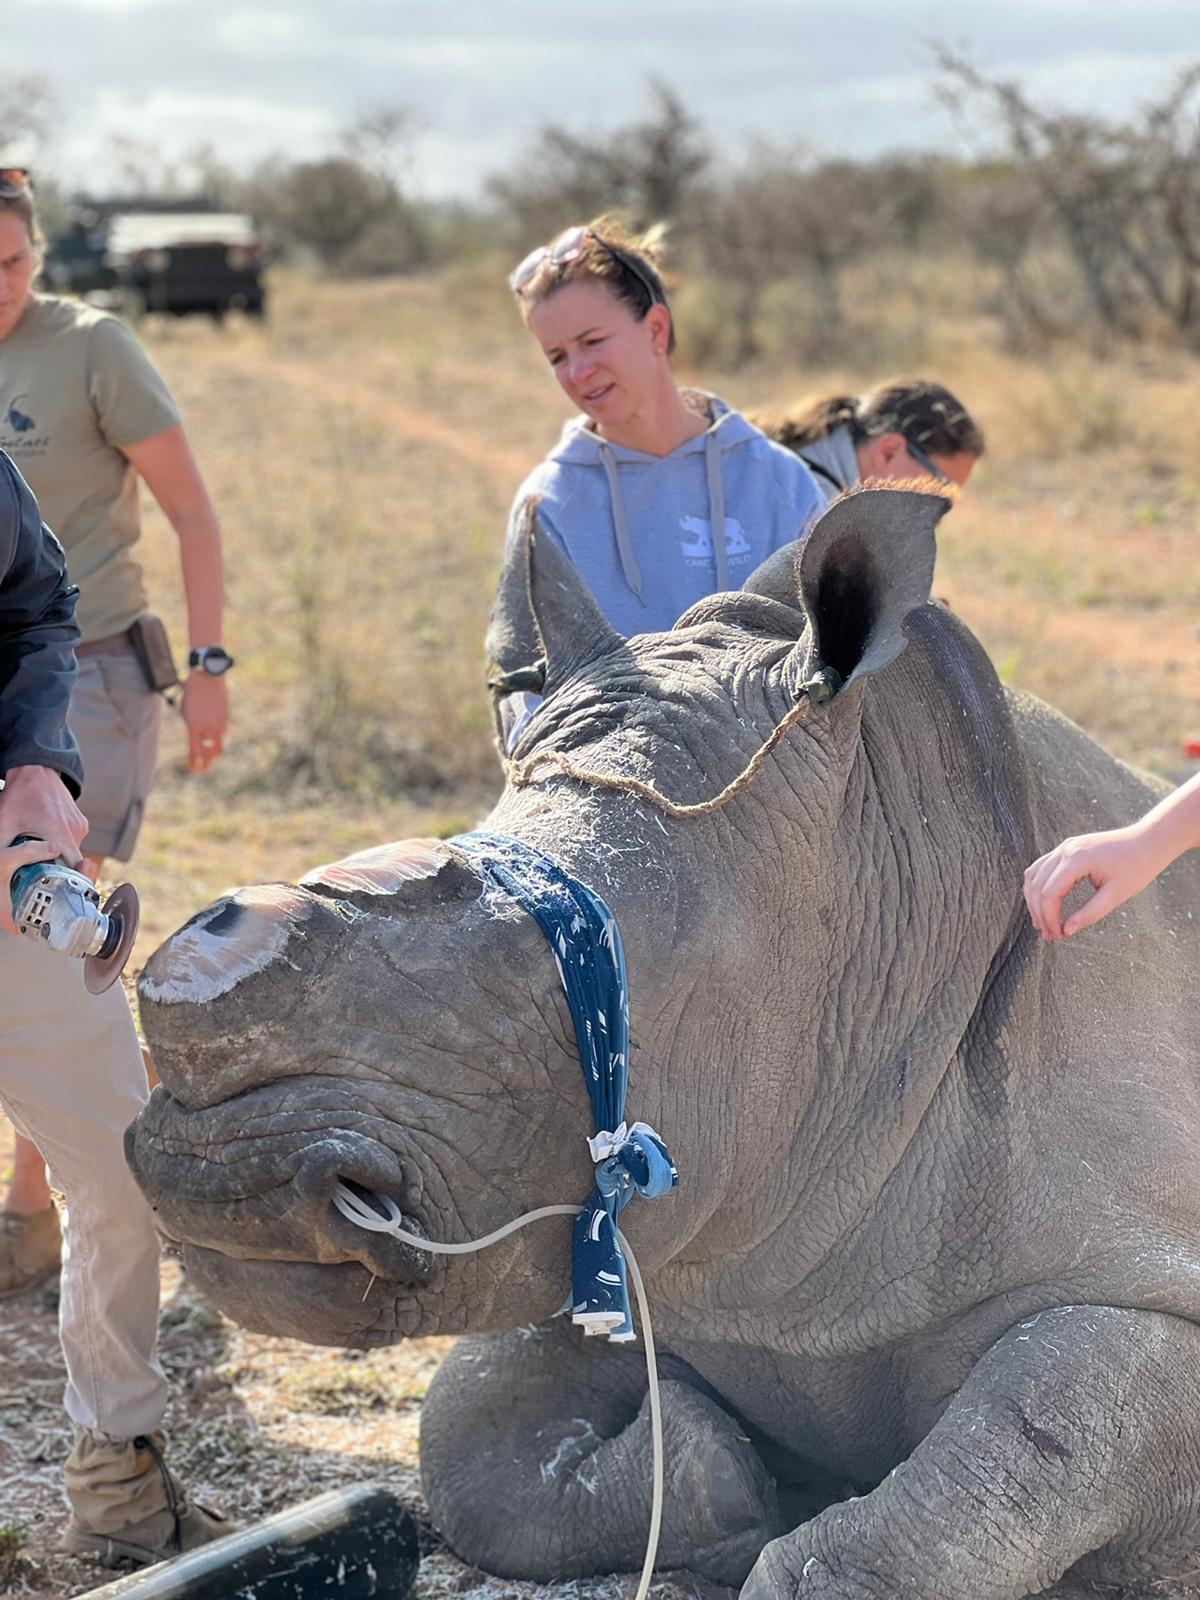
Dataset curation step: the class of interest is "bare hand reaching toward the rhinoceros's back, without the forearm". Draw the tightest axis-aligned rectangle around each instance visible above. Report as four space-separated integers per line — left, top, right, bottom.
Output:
1026 822 1166 939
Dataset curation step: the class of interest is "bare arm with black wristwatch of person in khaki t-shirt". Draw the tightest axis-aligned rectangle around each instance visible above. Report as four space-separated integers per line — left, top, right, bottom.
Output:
123 427 229 773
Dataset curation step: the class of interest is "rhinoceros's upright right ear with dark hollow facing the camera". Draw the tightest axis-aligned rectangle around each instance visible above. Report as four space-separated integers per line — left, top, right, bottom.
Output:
793 488 950 683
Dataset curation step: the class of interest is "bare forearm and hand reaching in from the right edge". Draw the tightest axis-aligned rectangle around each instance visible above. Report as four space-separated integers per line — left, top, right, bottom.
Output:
1026 773 1200 939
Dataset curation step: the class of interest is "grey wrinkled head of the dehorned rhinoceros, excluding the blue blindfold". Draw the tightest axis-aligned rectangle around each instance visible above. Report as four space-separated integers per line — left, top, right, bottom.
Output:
128 490 1024 1346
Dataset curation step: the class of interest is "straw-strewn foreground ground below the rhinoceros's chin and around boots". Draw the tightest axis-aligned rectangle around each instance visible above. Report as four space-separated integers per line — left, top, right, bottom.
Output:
0 1100 652 1600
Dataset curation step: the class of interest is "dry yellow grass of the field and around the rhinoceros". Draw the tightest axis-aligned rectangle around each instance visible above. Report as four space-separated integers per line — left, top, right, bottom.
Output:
0 268 1200 1600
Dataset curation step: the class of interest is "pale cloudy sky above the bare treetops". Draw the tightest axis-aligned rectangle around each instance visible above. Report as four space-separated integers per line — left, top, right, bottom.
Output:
9 0 1200 198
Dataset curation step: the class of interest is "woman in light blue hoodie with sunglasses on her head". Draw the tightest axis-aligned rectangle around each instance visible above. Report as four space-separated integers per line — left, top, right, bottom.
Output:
490 218 821 744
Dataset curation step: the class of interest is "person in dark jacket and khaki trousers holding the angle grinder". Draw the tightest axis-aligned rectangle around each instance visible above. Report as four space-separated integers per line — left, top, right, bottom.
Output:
0 451 230 1565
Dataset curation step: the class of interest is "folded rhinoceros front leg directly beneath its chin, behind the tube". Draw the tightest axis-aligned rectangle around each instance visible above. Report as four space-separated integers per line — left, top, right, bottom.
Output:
421 1322 786 1586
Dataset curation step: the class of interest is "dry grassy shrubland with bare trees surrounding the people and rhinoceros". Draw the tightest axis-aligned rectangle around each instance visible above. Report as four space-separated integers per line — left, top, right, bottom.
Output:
0 61 1200 1594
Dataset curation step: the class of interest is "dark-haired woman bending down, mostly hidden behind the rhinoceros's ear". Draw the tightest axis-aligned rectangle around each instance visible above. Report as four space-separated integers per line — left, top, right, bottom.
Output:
752 379 984 501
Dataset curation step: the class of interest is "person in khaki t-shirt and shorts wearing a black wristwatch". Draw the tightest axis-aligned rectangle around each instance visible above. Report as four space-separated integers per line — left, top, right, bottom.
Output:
0 170 229 1324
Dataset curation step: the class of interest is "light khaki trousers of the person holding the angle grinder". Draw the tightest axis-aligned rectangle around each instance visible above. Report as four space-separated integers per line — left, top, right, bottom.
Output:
0 931 166 1442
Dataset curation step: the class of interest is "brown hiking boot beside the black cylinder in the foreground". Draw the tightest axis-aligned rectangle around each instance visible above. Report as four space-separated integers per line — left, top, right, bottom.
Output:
61 1429 238 1566
